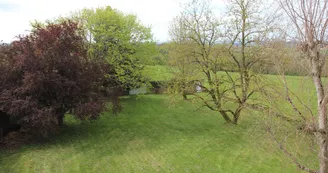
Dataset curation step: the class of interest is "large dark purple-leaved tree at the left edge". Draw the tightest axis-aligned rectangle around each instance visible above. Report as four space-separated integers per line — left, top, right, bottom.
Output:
0 21 114 138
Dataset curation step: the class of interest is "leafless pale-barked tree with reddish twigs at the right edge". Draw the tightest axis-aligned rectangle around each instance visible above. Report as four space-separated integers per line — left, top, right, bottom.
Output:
272 0 328 173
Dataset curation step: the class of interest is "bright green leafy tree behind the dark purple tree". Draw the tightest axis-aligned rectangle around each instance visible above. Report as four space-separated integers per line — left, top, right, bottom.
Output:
82 6 154 88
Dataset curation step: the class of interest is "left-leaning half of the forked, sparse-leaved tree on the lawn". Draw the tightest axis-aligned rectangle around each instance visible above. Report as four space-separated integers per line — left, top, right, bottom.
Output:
170 0 238 122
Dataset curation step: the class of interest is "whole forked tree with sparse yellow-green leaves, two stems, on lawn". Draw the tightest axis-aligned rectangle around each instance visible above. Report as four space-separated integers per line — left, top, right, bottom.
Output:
170 0 272 124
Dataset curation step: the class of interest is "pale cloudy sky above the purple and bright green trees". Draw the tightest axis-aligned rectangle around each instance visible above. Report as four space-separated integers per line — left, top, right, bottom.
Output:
0 0 226 42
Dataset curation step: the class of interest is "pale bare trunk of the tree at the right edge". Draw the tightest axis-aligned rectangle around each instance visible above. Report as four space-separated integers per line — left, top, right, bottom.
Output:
311 55 328 173
